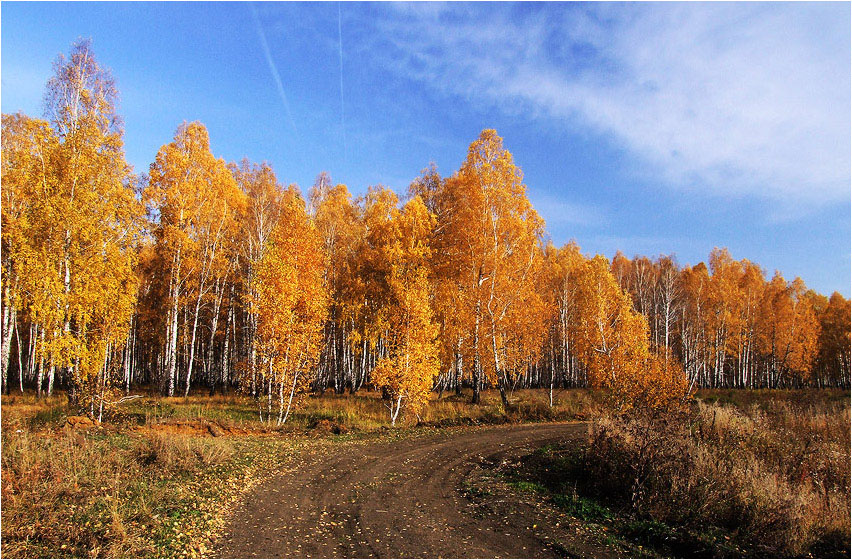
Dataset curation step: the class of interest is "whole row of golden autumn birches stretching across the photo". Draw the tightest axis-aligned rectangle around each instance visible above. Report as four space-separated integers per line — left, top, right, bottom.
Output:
2 41 850 422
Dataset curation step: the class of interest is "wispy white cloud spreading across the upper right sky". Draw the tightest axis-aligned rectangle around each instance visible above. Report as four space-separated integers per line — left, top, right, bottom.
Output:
363 3 852 205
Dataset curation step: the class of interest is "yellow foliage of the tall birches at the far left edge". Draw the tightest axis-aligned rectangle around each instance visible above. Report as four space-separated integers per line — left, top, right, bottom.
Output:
3 41 141 415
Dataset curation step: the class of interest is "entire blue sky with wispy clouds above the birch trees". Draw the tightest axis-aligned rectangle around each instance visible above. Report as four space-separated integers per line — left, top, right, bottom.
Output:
0 2 852 297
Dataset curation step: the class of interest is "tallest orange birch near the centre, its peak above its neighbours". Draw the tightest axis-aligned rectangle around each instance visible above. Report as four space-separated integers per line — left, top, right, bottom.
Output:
442 130 544 406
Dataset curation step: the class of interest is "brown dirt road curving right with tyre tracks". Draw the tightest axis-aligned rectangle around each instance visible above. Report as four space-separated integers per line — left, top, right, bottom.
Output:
217 423 586 558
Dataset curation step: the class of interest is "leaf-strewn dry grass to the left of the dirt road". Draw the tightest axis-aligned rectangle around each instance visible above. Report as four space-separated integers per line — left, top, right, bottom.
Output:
2 401 288 557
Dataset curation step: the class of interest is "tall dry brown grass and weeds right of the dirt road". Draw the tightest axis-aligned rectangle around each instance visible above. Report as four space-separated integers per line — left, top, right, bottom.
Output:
584 393 850 556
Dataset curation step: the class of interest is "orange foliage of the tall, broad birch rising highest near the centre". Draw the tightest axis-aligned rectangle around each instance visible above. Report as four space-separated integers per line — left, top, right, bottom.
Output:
432 130 544 404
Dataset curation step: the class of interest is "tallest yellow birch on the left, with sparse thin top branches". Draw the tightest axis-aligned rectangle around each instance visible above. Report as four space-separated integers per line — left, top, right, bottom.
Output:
27 41 140 416
